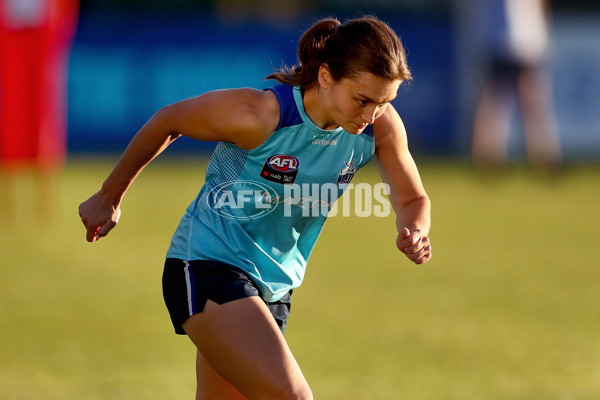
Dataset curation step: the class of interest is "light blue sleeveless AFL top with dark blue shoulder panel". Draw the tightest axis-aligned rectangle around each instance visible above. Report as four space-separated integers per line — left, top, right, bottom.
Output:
167 85 375 302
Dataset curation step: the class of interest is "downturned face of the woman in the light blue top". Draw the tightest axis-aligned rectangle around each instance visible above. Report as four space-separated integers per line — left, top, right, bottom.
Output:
319 67 401 134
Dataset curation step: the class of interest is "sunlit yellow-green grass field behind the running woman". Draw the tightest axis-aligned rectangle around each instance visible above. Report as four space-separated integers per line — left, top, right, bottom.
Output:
0 159 600 400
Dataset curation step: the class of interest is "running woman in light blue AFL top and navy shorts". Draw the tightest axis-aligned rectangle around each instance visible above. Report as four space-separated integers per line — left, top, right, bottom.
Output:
79 17 431 399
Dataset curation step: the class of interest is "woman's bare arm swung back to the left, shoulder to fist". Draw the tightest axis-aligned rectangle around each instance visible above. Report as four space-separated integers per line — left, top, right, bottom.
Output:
79 89 279 242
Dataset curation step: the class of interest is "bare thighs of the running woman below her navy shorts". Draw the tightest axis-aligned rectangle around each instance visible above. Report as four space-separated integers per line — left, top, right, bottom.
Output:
183 297 312 399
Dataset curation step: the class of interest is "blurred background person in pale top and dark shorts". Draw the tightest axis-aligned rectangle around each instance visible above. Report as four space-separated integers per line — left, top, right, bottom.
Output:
472 0 562 172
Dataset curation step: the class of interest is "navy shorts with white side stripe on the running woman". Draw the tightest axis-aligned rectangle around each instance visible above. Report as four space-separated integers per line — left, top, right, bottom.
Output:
162 258 292 335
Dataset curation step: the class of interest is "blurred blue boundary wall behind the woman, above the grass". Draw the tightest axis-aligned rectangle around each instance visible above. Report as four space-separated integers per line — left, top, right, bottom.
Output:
62 0 600 161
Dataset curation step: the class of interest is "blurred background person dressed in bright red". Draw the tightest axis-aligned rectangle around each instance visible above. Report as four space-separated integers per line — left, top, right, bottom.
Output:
0 0 79 220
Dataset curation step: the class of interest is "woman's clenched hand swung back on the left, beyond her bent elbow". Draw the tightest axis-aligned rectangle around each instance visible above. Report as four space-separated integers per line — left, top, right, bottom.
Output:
79 192 121 242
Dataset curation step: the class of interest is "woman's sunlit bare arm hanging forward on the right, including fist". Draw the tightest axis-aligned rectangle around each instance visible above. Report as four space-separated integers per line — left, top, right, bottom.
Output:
373 105 431 264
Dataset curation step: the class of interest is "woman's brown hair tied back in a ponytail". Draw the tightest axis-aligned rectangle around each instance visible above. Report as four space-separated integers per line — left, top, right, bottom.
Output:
266 16 412 87
